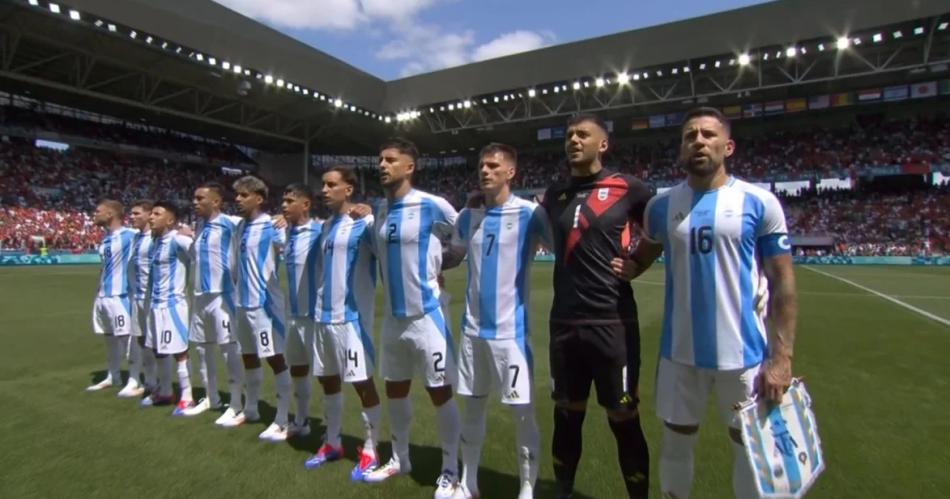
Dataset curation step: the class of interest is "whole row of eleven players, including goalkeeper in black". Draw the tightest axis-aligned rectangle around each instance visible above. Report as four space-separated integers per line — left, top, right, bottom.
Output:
91 109 795 499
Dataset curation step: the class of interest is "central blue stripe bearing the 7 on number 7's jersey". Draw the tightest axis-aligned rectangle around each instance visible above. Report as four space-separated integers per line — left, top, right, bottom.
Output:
480 211 502 339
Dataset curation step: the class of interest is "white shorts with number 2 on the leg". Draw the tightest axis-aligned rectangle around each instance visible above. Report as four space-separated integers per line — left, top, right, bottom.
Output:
380 308 458 387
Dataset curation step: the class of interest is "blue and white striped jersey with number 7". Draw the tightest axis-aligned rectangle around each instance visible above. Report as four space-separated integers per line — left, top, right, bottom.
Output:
452 194 551 340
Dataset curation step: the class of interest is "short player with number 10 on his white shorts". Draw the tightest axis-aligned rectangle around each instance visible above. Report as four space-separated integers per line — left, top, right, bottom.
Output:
142 201 195 416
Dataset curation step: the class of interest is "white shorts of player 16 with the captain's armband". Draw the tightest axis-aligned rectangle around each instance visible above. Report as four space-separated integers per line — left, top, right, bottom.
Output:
656 358 759 428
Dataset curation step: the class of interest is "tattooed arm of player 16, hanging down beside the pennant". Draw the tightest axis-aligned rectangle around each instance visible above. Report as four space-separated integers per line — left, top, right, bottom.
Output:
756 254 798 402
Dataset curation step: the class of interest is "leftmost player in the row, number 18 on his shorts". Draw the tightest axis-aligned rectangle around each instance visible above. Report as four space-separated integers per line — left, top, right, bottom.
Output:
86 199 135 392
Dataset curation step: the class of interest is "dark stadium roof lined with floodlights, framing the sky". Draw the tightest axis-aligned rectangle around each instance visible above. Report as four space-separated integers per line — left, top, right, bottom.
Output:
0 0 948 152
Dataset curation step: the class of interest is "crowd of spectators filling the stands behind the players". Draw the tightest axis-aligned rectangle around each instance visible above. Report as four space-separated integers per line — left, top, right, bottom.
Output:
0 111 950 255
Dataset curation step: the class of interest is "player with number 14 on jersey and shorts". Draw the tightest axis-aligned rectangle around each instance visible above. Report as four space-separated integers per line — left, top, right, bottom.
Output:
304 166 380 481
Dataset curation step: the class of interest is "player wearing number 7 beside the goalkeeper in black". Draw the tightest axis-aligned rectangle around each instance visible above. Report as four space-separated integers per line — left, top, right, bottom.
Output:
443 143 551 499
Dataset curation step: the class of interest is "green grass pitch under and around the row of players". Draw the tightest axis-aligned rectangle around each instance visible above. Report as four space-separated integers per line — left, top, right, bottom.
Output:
0 264 950 499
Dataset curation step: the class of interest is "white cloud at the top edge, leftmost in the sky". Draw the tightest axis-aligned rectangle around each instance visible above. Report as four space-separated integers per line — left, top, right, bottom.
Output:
215 0 437 30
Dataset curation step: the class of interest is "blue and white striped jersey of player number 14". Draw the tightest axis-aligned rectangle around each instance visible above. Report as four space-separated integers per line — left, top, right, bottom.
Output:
314 214 376 331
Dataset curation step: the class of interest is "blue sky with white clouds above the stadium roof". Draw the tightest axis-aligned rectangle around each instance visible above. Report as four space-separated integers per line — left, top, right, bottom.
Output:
215 0 763 80
